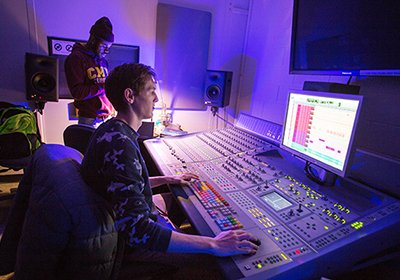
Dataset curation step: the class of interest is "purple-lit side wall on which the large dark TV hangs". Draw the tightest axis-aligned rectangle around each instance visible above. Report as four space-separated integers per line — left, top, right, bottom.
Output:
238 0 400 159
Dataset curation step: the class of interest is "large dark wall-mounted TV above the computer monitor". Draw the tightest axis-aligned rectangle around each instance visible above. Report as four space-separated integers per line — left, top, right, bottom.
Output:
289 0 400 76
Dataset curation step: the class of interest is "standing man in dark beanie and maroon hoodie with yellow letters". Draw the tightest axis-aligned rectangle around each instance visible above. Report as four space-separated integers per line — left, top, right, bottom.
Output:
64 17 114 127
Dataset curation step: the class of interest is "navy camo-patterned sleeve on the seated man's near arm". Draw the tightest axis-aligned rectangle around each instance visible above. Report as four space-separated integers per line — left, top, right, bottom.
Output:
83 120 171 251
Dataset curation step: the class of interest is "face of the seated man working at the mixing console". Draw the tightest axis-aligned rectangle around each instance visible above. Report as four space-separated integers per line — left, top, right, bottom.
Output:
133 78 158 120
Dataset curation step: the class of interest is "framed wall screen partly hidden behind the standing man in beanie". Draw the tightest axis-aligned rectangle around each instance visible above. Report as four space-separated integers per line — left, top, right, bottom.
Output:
47 37 140 99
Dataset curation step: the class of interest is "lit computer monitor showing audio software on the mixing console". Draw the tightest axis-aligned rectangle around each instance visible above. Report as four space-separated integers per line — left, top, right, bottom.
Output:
281 90 362 177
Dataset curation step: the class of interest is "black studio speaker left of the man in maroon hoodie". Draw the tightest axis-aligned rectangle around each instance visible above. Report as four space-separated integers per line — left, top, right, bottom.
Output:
25 53 58 102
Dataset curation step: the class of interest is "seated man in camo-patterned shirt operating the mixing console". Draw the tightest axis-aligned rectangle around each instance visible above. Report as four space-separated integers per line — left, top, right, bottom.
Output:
81 64 258 275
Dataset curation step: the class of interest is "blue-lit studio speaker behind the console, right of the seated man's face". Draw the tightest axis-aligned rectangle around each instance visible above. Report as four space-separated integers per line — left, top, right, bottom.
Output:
204 70 233 107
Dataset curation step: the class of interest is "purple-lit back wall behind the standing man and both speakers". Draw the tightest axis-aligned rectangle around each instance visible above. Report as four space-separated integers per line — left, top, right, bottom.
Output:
0 0 249 143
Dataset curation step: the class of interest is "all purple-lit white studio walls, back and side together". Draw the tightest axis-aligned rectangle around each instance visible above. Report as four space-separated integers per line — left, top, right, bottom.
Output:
0 0 400 158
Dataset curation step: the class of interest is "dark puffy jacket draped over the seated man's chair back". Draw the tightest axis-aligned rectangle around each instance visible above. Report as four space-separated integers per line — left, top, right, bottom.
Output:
0 144 118 279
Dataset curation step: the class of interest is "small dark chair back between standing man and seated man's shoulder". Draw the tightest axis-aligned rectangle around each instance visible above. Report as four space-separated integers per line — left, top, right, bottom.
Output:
63 124 95 154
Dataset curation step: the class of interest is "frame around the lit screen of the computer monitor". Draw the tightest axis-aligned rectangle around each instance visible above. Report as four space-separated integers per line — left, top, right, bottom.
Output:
280 90 363 177
